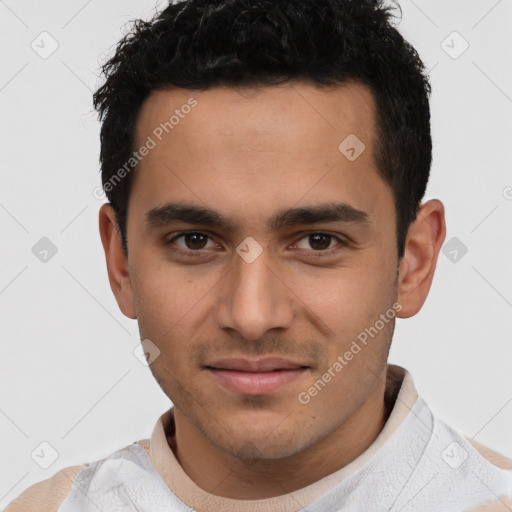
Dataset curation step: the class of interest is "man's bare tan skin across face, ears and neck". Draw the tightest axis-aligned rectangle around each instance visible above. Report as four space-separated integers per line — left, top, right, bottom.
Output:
99 82 446 499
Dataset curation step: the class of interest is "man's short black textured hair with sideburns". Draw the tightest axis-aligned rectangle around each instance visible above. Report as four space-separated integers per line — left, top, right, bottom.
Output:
93 0 432 259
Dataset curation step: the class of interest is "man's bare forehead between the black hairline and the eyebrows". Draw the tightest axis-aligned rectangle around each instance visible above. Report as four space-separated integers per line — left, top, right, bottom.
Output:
130 83 391 230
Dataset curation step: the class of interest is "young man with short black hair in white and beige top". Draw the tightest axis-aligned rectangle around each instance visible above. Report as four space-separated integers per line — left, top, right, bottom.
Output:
7 0 512 512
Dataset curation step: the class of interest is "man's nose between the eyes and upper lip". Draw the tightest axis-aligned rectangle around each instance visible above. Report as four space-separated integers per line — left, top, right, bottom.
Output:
216 244 294 340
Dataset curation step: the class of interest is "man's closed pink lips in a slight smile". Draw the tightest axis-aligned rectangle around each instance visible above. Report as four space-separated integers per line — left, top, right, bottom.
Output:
205 357 311 396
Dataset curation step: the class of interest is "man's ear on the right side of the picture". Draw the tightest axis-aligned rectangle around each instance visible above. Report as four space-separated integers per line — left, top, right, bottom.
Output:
397 199 446 318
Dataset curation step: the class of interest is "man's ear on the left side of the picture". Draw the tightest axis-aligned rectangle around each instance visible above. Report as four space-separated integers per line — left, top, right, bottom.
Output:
99 204 137 319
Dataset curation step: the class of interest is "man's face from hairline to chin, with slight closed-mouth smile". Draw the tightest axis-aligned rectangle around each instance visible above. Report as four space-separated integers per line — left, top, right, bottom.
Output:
113 83 404 458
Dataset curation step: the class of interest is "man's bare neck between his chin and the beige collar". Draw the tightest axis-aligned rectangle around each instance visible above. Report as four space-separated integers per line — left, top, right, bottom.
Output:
168 381 392 500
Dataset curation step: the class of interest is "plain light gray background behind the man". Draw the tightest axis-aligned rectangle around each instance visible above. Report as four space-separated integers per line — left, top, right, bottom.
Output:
0 0 512 506
